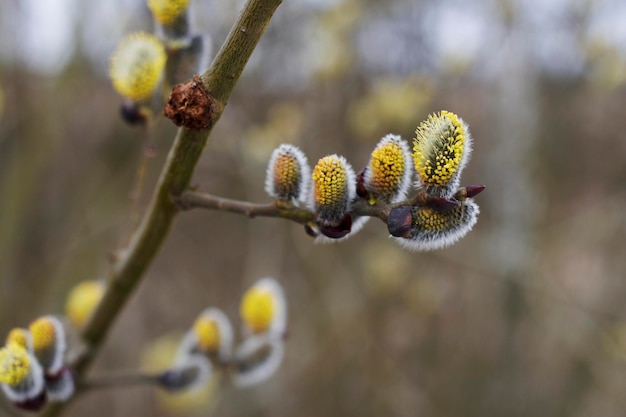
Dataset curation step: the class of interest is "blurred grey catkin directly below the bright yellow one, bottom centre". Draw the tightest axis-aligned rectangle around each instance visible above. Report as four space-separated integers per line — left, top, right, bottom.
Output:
233 334 285 387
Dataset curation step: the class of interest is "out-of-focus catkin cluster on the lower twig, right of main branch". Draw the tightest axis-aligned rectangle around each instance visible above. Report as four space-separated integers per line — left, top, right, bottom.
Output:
157 277 287 392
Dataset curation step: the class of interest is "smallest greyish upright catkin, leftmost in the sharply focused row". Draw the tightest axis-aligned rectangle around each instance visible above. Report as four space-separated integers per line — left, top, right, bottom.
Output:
265 144 311 202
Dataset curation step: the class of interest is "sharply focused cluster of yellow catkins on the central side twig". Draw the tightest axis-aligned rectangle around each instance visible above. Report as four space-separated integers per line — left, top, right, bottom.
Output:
265 111 484 250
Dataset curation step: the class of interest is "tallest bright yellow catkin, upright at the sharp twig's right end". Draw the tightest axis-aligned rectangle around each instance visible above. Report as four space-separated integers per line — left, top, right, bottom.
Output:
413 110 472 198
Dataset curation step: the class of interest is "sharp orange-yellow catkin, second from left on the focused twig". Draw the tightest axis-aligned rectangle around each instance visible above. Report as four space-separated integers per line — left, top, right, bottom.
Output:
311 155 356 225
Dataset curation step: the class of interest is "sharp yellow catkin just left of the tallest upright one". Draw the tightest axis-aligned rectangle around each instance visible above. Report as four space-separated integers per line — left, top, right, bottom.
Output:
363 134 413 204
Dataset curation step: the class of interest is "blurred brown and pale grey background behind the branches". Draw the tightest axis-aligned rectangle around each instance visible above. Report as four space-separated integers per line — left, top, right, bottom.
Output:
0 0 626 417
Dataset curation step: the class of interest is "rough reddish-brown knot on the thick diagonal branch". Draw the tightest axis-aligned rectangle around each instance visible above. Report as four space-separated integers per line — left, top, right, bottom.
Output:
163 75 221 130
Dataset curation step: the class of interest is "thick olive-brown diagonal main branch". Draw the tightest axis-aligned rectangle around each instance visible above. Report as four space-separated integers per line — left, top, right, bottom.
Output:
45 0 281 417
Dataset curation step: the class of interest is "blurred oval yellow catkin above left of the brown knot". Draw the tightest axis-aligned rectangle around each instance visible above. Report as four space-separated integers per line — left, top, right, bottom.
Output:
109 32 167 101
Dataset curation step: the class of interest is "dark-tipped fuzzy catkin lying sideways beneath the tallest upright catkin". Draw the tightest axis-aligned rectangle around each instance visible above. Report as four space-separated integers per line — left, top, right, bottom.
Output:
387 199 480 251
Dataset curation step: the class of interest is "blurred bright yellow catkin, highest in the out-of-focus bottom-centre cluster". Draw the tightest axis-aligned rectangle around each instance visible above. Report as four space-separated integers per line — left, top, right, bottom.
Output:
239 278 287 335
